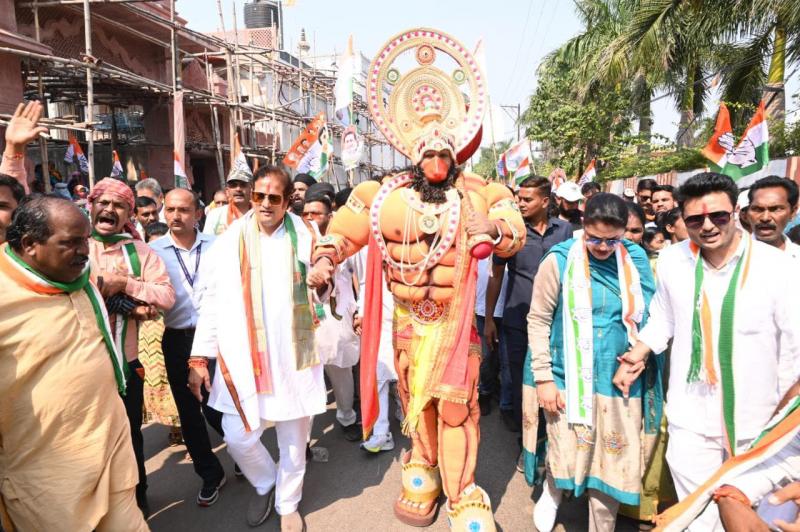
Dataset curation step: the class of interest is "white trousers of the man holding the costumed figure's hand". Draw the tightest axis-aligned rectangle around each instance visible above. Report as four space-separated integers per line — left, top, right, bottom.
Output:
222 414 311 515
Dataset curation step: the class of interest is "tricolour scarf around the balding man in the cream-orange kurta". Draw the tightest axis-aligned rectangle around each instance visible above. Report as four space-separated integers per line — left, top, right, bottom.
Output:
0 244 127 395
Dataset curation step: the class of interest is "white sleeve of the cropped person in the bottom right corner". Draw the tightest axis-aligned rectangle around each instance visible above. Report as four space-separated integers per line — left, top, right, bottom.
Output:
731 435 800 504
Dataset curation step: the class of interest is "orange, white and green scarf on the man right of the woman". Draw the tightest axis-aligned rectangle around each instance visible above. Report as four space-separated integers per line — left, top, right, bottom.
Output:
686 234 753 454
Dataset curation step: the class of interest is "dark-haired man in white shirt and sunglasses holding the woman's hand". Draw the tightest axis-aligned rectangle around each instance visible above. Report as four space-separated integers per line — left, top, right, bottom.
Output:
614 172 800 530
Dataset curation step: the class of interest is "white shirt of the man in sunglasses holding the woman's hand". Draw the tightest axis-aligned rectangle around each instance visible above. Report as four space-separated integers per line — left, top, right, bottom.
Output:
639 232 800 440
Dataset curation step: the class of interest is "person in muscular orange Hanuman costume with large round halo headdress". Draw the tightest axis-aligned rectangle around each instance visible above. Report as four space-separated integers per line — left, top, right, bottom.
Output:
309 29 525 532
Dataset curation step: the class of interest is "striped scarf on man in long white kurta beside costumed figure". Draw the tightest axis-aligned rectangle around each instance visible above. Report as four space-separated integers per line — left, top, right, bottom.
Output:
239 214 319 394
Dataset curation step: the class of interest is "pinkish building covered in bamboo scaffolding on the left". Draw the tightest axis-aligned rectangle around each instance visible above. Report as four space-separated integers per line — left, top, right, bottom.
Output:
0 0 405 197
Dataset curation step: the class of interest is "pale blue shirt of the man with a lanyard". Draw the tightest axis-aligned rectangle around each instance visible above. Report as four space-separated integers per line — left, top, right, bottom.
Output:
150 231 215 329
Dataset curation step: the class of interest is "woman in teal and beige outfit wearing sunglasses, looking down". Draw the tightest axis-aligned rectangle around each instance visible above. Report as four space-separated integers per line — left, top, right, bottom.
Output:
525 193 661 532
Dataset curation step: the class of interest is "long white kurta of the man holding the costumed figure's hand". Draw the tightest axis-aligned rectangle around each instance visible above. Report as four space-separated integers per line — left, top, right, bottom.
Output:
192 213 326 427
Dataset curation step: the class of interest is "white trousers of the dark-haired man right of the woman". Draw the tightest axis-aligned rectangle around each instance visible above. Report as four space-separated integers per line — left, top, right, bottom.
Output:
667 425 751 532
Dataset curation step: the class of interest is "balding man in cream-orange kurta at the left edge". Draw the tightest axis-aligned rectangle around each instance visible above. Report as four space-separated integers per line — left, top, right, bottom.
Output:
0 197 148 532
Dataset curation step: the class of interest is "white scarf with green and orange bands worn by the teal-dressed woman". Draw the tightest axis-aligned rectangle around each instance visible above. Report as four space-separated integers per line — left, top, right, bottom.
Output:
562 239 644 426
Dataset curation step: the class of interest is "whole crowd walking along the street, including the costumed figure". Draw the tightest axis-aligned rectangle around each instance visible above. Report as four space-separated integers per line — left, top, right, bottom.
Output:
0 90 800 532
